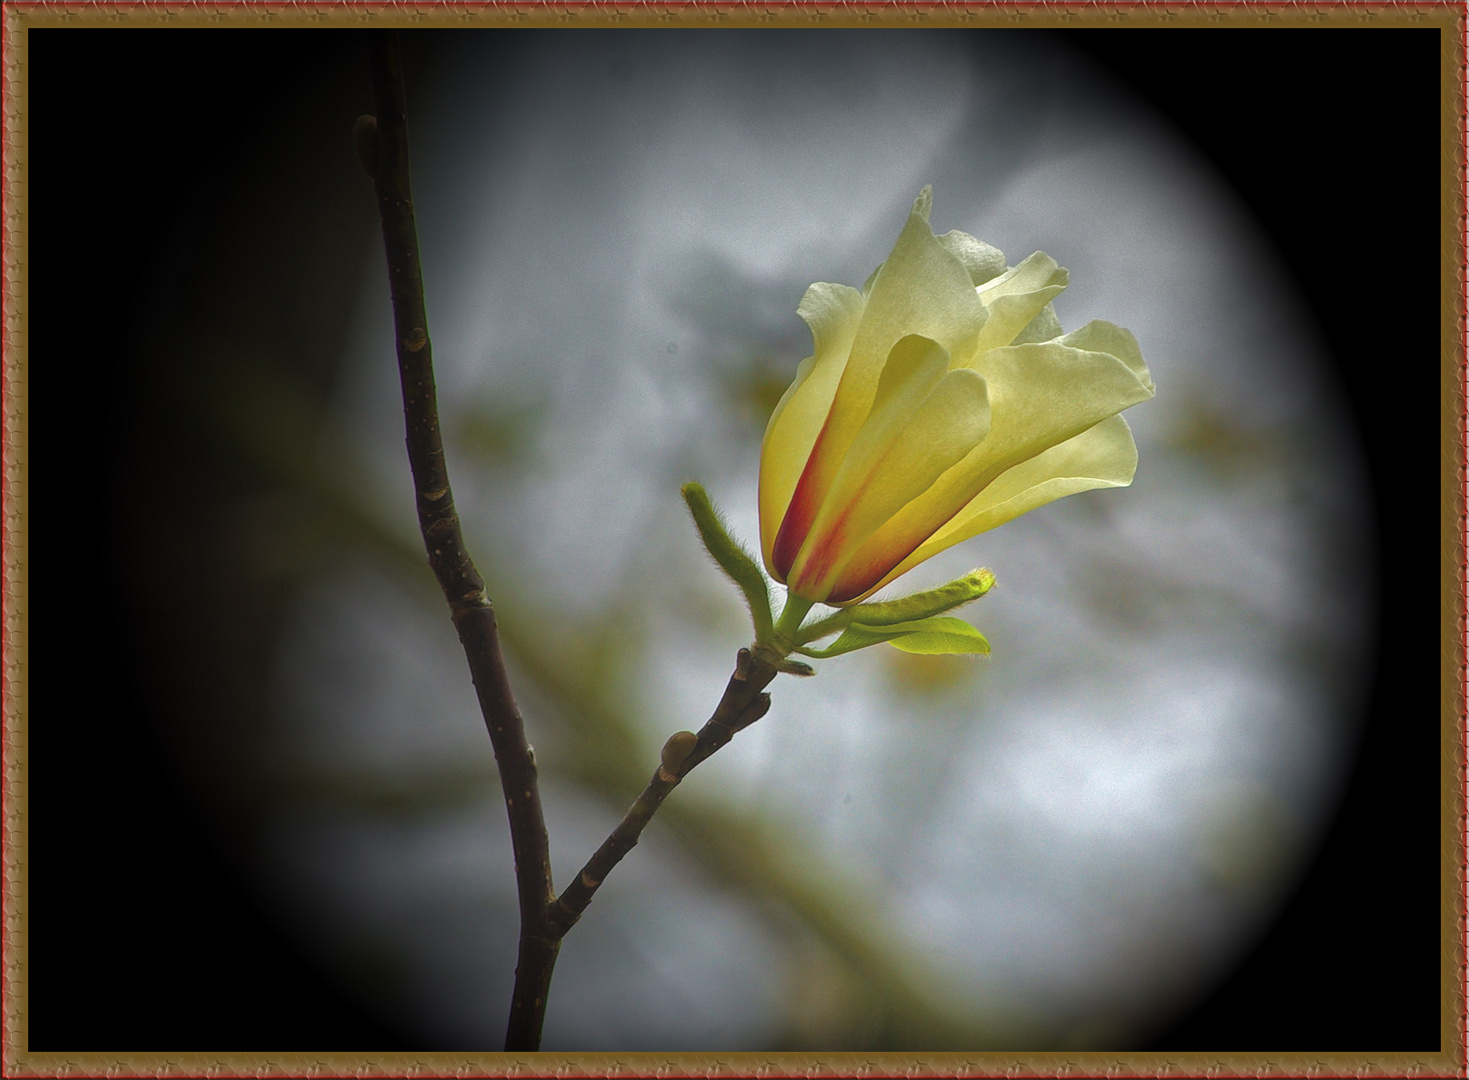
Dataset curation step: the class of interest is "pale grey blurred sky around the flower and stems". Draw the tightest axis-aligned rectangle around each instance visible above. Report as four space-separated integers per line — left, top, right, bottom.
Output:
243 32 1366 1049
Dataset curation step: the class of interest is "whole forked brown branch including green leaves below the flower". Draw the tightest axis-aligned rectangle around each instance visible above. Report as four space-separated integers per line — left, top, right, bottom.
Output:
362 31 995 1051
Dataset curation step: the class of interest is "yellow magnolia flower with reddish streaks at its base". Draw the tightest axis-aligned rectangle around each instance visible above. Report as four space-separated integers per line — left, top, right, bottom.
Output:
759 188 1153 605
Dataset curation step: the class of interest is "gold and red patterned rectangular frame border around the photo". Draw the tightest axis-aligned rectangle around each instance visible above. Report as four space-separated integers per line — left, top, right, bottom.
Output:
0 0 1469 1080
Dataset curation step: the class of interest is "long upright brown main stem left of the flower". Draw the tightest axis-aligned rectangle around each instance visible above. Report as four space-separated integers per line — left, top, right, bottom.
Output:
355 31 560 1051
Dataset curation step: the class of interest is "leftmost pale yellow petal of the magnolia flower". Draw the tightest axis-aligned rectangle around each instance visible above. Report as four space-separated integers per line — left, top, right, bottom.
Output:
759 282 864 573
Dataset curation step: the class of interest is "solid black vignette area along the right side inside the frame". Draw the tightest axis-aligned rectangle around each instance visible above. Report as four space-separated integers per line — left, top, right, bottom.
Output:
1078 29 1451 1051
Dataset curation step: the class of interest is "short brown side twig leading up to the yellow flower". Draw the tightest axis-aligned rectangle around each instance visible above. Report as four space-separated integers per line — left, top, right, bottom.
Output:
548 649 777 936
